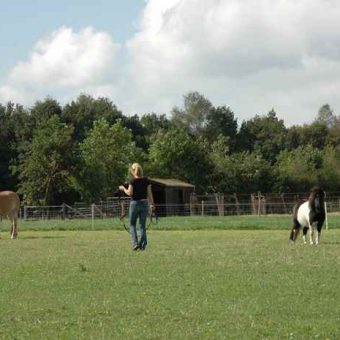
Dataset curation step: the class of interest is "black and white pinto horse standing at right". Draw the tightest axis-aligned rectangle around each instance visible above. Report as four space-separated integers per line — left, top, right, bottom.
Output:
290 187 326 244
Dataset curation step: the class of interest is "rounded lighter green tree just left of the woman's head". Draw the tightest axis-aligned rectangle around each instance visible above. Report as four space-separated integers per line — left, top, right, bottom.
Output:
78 118 138 201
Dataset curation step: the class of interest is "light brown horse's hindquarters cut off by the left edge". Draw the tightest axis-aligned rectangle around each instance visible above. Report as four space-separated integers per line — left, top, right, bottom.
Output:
0 191 20 239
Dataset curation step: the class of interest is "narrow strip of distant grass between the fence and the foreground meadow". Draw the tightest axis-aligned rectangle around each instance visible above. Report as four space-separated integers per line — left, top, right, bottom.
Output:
1 215 340 231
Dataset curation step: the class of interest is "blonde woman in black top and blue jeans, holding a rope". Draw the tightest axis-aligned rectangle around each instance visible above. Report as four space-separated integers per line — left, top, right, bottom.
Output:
119 163 154 250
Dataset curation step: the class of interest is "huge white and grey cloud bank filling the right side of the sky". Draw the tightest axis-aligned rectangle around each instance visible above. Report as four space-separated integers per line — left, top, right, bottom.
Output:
127 0 340 124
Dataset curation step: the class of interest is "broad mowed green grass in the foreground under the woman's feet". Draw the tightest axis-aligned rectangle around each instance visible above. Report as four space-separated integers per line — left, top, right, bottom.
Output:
0 222 340 339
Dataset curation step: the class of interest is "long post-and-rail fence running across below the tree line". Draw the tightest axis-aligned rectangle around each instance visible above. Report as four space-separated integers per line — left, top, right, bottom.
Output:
20 193 340 220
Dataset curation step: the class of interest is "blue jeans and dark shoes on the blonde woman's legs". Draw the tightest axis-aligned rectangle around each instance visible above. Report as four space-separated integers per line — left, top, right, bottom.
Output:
129 200 149 249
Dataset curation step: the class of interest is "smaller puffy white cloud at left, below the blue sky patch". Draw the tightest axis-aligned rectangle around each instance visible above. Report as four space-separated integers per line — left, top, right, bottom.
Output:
0 27 120 104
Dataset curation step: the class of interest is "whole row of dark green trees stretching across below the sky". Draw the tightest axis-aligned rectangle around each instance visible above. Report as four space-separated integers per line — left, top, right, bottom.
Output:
0 92 340 205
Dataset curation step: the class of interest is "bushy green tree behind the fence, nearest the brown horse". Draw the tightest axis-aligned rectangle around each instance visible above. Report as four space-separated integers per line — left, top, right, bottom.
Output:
15 116 73 205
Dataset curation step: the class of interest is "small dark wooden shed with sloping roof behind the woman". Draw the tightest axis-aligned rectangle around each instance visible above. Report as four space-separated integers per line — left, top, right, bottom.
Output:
150 178 195 215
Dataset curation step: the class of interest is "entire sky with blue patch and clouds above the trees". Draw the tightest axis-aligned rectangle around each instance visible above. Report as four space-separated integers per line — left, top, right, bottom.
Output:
0 0 340 125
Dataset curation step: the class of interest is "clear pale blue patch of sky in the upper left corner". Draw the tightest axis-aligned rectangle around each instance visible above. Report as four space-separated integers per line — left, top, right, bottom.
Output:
0 0 145 77
